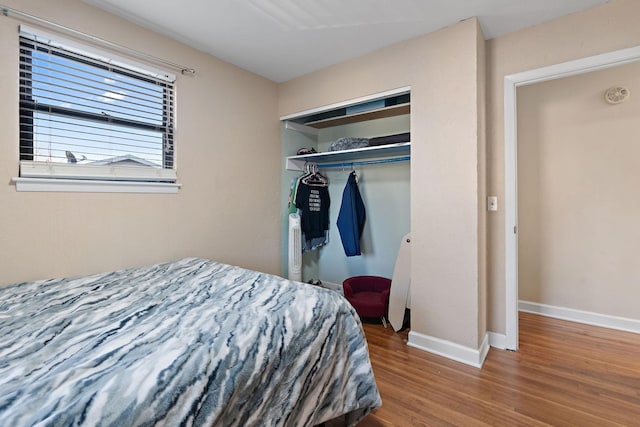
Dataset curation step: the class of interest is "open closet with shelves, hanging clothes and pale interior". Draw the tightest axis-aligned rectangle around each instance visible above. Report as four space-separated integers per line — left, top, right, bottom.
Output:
281 88 411 332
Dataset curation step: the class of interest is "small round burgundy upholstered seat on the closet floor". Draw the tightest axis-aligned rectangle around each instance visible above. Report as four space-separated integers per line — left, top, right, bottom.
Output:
342 276 391 328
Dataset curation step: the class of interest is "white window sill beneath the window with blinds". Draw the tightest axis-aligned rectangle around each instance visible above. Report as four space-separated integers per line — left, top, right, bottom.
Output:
11 177 182 193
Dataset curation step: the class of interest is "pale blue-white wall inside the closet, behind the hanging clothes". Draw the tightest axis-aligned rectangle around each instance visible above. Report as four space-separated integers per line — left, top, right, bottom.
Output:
282 114 410 285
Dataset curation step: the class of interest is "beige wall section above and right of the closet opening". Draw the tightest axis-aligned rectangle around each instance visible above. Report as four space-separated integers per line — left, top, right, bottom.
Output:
279 19 485 349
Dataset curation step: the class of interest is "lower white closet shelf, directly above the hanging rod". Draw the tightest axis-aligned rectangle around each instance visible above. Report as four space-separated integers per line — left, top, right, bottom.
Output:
286 142 411 171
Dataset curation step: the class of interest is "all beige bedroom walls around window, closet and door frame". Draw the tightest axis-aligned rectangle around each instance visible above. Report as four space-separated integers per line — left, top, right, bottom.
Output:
0 0 640 358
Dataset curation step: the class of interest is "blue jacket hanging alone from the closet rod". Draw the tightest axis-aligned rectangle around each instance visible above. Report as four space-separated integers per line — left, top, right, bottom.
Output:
338 172 367 256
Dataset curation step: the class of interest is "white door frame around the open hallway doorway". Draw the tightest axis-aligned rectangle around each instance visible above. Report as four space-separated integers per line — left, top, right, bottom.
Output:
504 46 640 351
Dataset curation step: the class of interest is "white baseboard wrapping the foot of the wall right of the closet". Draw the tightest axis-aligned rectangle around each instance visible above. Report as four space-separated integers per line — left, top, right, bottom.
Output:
407 331 489 368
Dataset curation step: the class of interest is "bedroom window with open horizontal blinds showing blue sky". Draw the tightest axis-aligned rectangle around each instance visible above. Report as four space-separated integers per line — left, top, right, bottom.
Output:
14 26 178 192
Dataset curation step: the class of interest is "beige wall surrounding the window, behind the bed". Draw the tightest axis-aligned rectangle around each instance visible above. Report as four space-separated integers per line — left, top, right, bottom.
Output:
0 0 281 284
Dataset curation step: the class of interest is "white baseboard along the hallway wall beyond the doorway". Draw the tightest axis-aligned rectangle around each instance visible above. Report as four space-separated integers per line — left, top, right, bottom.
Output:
518 300 640 334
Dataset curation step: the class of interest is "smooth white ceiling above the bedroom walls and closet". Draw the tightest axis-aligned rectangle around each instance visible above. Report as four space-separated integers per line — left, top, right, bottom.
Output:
83 0 608 82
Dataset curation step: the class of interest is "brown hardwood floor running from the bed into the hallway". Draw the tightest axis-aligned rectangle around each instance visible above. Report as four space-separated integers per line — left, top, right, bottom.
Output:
358 313 640 427
